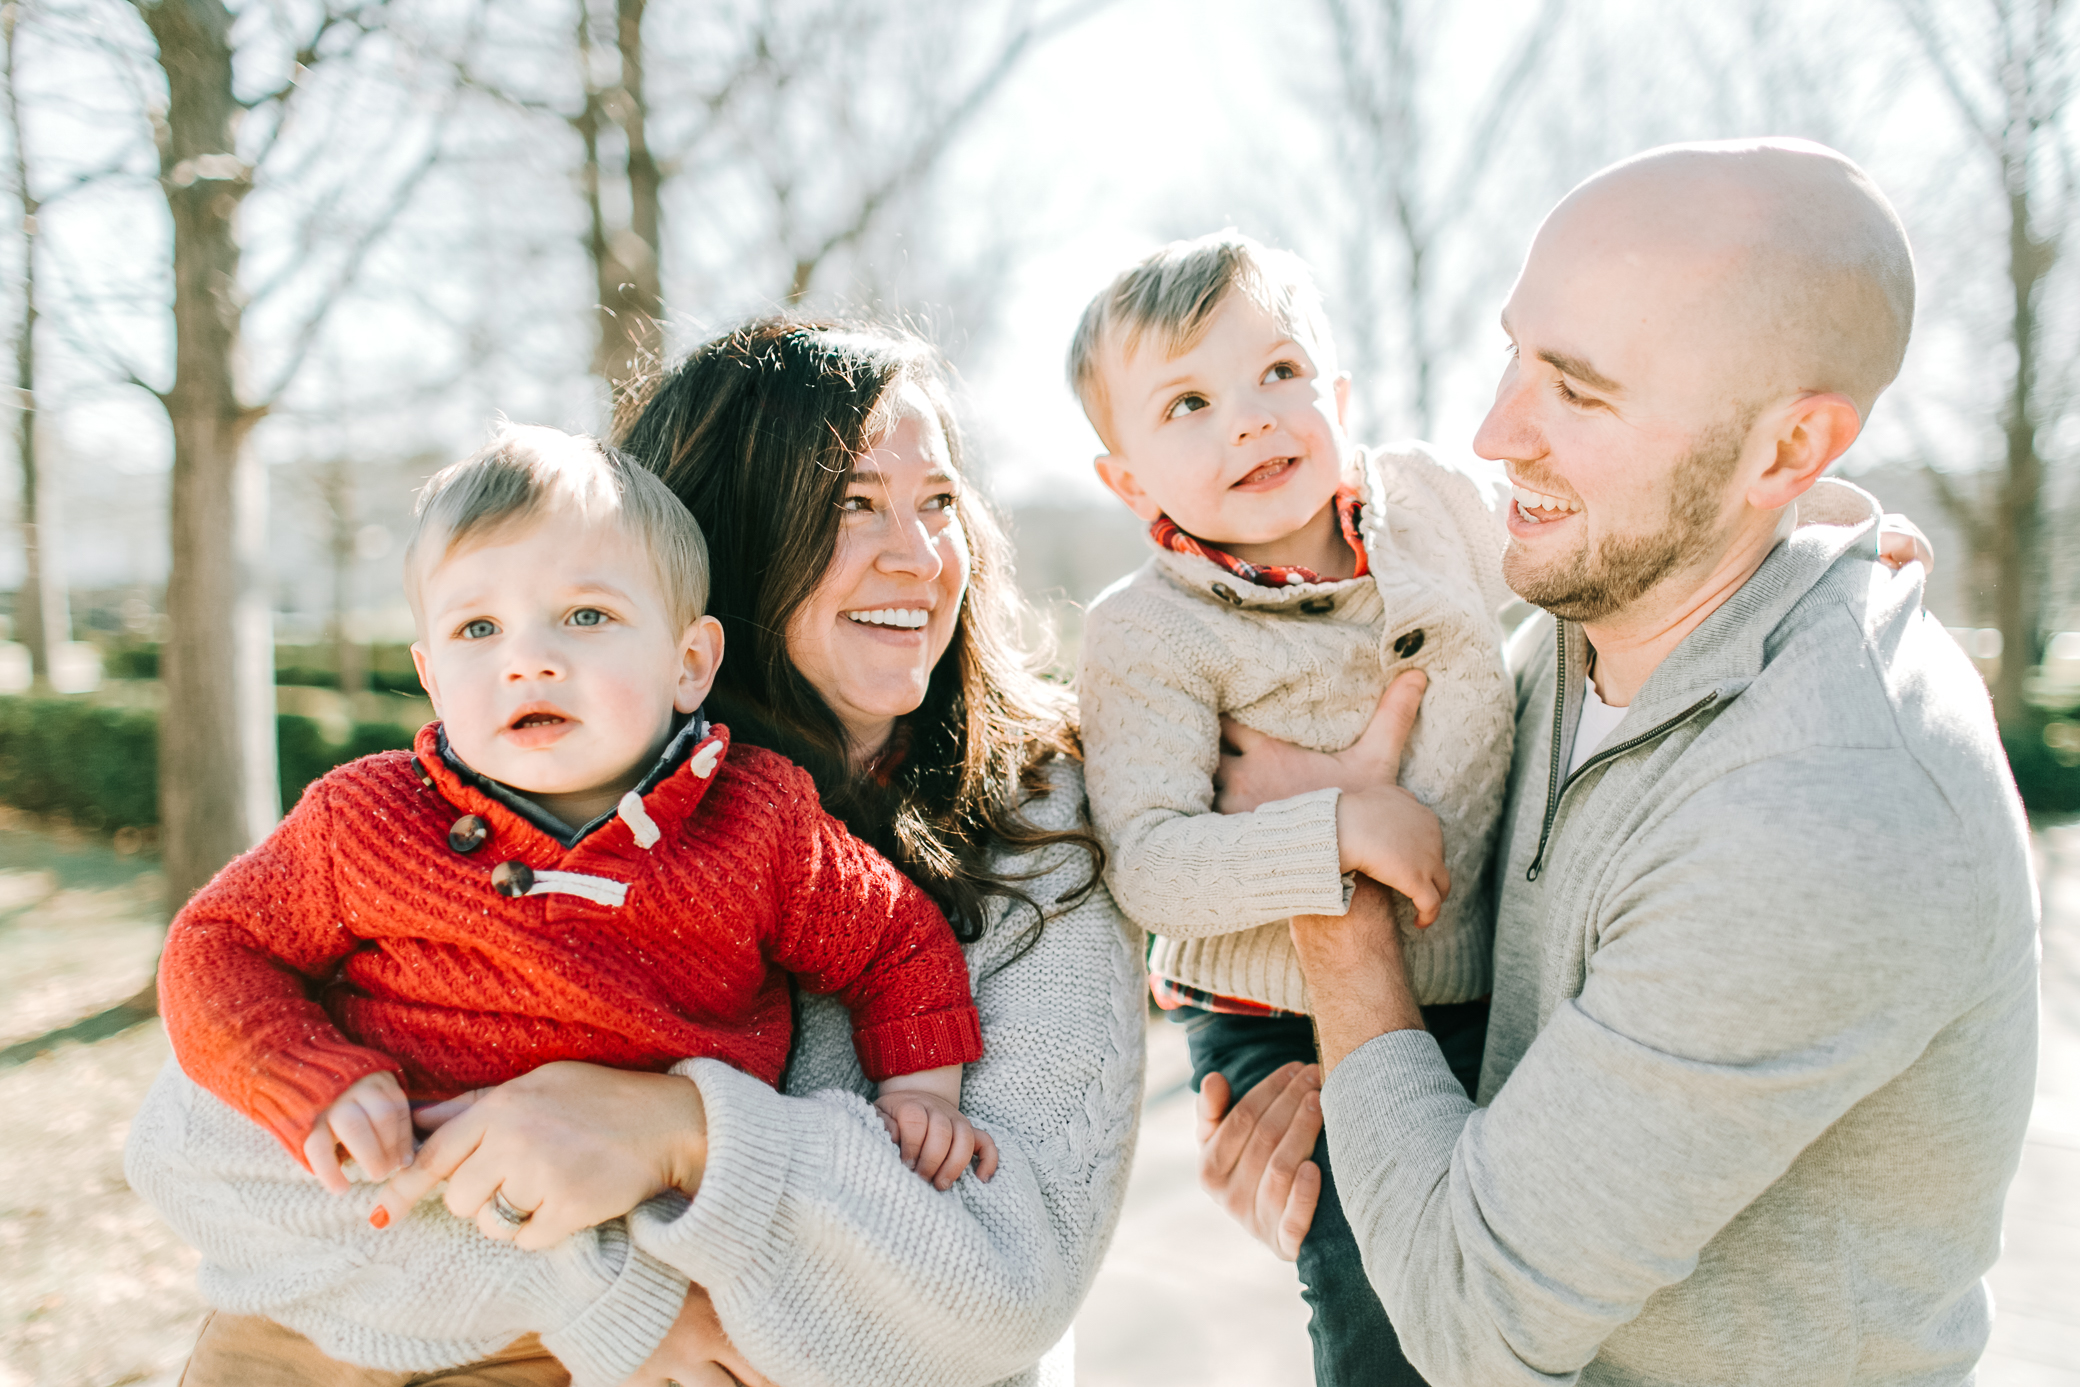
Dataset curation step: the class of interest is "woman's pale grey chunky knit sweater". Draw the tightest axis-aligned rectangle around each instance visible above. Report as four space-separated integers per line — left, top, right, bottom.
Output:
127 765 1144 1387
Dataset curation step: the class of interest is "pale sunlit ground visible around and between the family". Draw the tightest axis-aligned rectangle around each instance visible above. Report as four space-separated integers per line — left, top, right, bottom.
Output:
0 817 2080 1387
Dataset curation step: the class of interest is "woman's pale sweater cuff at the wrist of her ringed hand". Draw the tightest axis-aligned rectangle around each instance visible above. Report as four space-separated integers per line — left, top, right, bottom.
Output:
628 1058 826 1293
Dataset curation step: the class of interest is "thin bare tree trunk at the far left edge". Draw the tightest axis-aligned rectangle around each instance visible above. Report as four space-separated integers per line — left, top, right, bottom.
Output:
0 4 73 686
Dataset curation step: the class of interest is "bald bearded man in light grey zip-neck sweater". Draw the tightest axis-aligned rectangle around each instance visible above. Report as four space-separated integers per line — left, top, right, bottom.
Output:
1206 143 2036 1387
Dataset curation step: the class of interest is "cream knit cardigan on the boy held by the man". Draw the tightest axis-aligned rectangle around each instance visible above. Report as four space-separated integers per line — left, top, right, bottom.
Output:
1077 443 1516 1011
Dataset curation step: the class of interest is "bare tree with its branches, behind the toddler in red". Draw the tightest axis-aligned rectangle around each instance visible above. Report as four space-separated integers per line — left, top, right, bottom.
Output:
131 0 451 923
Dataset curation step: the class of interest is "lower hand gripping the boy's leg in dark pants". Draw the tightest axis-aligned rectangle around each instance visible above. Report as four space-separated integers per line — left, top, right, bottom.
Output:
1198 1063 1321 1262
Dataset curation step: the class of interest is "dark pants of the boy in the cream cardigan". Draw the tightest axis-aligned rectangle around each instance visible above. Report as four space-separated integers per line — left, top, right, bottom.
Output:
1171 998 1487 1387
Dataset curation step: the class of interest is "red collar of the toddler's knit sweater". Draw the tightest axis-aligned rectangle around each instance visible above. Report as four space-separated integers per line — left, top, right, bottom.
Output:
412 711 730 850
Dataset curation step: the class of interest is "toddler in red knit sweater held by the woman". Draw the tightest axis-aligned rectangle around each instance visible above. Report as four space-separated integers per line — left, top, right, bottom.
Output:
158 428 996 1225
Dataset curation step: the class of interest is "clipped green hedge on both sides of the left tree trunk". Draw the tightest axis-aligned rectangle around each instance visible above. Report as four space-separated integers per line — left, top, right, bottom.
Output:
0 697 412 832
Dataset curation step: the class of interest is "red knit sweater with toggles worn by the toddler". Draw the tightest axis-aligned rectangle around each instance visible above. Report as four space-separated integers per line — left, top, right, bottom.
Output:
158 724 982 1158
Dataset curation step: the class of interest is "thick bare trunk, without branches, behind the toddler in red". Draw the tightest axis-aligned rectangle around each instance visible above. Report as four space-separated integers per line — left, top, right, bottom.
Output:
141 0 281 923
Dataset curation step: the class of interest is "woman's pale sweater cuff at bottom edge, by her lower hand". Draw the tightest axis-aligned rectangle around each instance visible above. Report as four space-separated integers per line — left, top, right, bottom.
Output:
541 1222 688 1387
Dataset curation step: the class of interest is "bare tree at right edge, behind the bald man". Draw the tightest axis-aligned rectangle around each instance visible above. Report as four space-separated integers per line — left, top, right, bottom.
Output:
1895 0 2080 726
